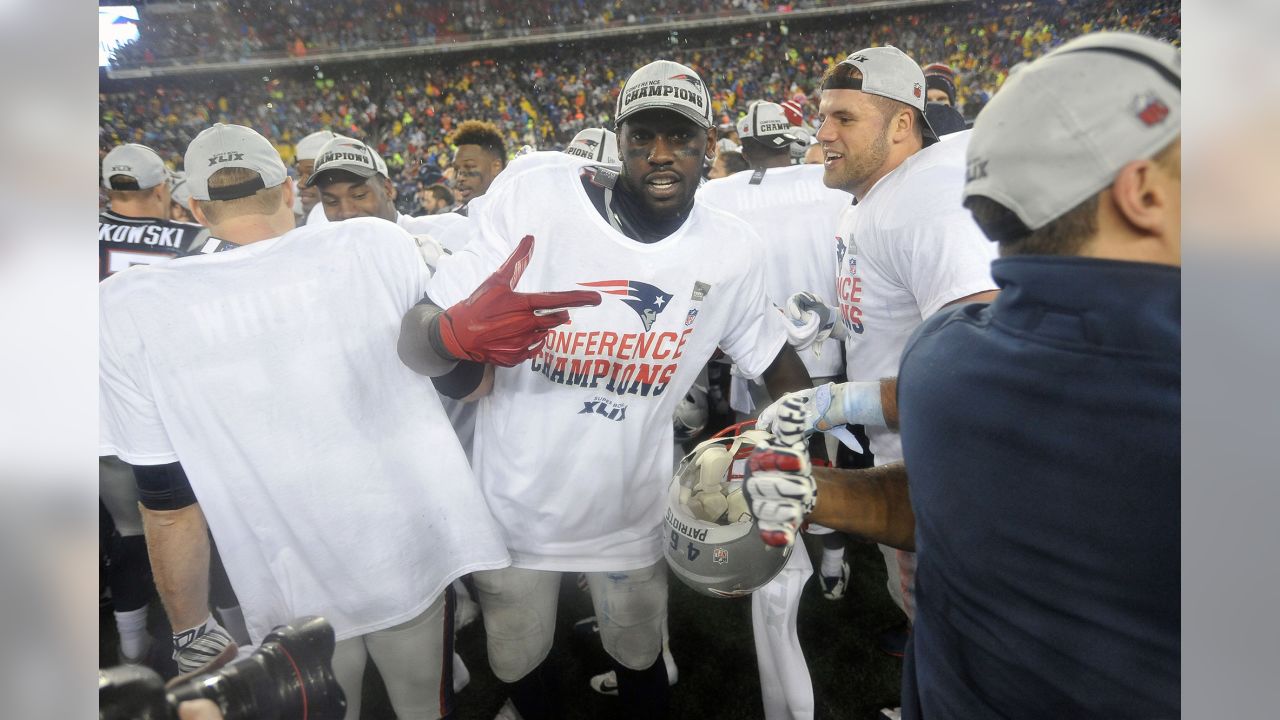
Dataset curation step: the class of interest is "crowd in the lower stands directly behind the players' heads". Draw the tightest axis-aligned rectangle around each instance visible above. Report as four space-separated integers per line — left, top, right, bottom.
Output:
99 0 1181 211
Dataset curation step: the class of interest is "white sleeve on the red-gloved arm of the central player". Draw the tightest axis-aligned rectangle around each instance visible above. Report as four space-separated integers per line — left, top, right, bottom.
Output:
426 176 517 307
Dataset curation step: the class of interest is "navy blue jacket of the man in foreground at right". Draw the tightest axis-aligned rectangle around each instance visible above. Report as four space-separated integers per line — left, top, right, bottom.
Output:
899 256 1181 720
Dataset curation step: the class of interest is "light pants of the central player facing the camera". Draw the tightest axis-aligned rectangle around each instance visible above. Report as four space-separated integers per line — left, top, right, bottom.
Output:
472 560 667 683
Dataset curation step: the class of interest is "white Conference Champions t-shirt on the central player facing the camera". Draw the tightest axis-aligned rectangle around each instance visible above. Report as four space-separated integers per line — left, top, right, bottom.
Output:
428 152 786 571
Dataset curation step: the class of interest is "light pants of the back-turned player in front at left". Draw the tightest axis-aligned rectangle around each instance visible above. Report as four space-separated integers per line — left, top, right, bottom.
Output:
333 591 453 720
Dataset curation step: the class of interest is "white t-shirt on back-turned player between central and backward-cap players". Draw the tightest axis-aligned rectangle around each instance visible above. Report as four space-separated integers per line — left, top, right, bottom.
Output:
698 165 854 378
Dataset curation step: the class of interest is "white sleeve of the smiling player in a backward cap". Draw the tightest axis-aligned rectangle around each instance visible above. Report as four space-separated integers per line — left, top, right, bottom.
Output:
892 205 997 319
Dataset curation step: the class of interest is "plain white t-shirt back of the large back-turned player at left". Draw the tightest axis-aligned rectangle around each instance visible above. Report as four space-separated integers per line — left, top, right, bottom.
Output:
99 218 508 642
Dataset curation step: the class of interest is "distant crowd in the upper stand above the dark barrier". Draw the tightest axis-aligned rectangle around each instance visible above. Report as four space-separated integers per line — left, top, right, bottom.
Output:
114 0 835 67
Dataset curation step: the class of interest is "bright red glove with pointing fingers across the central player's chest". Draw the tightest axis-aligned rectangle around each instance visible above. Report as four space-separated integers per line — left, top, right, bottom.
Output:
440 234 600 368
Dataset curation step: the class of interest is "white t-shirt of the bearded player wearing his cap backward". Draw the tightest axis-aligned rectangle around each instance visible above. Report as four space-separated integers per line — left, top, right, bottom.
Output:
836 131 996 465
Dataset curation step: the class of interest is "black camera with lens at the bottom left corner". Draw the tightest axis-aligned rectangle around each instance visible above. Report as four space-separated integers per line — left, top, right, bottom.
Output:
97 609 347 720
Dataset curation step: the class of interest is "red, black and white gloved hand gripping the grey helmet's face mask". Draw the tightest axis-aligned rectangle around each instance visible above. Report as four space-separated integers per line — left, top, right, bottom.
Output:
742 398 818 547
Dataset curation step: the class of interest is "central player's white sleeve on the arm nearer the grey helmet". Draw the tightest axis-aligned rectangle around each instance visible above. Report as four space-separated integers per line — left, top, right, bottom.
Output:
719 231 787 379
